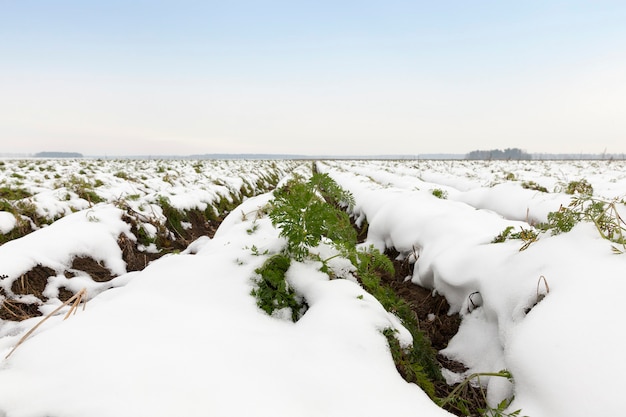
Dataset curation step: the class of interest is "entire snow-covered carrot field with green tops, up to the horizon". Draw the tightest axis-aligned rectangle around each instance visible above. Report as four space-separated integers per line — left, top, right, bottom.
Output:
0 159 626 417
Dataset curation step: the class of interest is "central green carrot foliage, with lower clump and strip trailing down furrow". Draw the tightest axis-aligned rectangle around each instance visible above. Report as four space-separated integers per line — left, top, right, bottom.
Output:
260 172 442 398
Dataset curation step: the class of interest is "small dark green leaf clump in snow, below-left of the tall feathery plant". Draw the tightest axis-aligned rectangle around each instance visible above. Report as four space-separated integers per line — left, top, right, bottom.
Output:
252 254 306 322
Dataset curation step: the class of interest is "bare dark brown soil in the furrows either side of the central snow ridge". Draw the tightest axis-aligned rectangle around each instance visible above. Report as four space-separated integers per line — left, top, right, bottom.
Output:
0 201 482 415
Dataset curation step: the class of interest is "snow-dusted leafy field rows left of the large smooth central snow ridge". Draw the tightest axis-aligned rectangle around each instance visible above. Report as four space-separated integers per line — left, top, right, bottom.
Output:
0 160 310 320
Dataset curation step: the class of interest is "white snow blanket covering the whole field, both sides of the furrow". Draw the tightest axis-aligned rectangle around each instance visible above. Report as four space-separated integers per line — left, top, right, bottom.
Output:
0 161 626 417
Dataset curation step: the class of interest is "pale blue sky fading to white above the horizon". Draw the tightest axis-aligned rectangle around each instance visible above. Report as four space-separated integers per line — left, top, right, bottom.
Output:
0 0 626 155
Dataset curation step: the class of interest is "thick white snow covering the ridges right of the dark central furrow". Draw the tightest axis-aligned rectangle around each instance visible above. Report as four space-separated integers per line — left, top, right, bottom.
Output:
314 160 626 417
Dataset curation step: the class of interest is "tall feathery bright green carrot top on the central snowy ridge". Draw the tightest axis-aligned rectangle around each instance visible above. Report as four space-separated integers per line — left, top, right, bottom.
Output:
269 173 356 261
